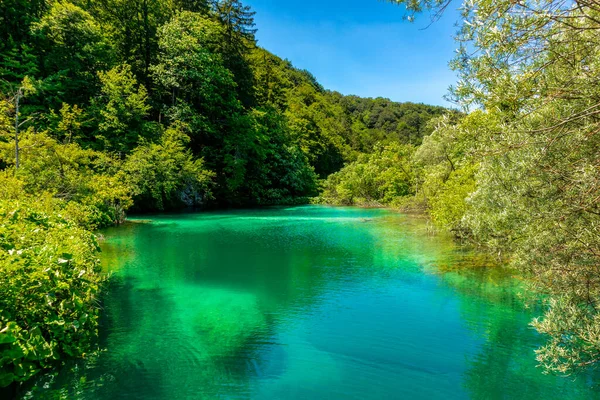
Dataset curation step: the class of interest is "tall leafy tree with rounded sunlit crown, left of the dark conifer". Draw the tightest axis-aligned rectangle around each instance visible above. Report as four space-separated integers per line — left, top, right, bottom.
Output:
152 12 241 139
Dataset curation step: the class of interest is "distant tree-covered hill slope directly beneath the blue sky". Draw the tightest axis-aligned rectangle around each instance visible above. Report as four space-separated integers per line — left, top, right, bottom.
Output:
250 48 447 178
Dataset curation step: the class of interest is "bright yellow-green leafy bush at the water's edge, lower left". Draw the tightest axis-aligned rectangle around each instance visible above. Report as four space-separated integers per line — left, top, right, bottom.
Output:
0 181 102 387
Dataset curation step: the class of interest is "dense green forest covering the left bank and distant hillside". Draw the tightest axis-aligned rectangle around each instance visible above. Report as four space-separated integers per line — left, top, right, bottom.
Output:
0 0 447 387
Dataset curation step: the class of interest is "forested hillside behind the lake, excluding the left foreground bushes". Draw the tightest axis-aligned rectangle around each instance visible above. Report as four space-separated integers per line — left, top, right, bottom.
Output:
0 0 444 210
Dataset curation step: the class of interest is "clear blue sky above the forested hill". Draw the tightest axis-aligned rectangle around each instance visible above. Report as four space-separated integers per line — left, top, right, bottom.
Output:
244 0 459 105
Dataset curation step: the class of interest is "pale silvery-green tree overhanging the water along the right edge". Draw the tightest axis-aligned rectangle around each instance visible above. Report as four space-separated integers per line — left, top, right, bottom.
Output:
384 0 600 373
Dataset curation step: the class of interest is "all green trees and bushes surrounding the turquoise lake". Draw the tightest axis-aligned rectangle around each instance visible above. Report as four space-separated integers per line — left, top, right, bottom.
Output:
0 0 600 393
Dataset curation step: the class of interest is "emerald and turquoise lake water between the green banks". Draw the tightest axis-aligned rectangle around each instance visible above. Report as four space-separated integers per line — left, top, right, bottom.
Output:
30 206 600 400
